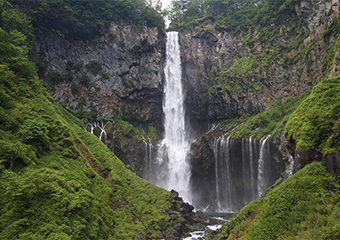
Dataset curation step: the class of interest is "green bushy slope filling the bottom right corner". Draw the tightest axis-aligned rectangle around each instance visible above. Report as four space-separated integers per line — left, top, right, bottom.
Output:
220 163 340 240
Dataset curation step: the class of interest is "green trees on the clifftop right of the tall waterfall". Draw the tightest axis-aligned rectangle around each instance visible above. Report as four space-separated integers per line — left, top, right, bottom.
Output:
169 0 297 32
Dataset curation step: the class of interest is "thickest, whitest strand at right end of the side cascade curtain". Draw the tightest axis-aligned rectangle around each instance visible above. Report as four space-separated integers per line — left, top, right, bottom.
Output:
257 135 270 198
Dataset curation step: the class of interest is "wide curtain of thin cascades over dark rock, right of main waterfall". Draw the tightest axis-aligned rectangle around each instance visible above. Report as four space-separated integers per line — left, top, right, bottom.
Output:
209 136 277 212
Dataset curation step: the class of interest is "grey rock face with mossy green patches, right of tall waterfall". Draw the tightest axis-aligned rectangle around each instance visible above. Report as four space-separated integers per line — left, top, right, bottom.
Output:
180 0 339 124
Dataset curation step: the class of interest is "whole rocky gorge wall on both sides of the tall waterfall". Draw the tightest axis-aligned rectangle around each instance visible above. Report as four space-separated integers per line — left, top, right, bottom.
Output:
37 0 339 207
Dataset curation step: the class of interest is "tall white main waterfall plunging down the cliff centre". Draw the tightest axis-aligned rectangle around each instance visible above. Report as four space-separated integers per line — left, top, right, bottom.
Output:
156 32 191 202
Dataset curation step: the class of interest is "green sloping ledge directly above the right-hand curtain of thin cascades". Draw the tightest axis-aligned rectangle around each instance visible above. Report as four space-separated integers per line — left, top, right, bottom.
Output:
227 91 310 139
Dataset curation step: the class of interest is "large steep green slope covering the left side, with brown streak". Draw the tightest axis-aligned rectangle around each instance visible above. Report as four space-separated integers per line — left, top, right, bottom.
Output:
0 1 199 239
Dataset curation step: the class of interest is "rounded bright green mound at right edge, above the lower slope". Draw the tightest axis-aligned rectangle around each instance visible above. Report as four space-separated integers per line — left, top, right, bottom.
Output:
285 76 340 154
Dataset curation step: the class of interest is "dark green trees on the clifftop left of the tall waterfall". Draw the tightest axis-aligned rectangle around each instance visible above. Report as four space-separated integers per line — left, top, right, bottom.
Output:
10 0 164 39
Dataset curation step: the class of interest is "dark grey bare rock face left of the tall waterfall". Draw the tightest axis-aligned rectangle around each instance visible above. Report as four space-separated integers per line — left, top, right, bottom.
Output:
37 23 165 122
